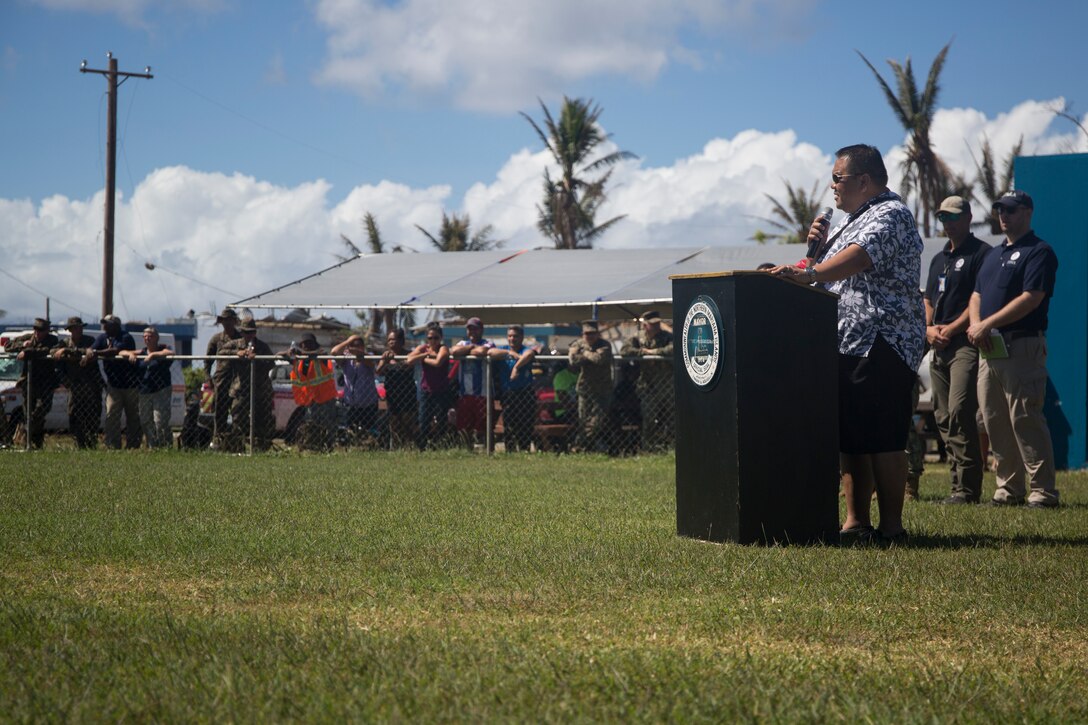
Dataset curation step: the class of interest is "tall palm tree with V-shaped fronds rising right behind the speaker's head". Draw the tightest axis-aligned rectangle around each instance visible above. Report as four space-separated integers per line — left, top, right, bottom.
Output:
857 40 952 235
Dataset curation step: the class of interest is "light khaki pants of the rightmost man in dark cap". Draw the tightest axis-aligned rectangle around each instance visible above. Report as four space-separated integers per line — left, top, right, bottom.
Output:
978 336 1058 504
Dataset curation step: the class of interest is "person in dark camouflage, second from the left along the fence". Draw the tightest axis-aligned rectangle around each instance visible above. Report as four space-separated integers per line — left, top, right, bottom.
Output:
53 317 102 448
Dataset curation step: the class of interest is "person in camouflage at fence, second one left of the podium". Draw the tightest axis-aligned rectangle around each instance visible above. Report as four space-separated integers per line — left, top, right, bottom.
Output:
569 320 613 451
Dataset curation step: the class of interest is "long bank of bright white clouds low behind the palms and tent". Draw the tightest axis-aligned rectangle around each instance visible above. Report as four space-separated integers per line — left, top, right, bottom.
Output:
0 101 1088 320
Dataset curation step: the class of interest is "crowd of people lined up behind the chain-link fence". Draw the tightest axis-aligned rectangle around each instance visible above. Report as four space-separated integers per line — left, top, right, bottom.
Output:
0 308 673 455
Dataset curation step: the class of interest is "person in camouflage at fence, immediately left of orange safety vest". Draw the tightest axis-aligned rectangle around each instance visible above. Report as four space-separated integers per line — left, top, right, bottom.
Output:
220 317 275 453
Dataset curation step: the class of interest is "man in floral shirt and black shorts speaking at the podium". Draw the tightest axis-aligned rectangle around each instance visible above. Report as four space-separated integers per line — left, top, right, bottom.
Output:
771 145 925 545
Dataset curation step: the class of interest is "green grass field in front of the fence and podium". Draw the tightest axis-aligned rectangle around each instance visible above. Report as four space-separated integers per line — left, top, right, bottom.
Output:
0 452 1088 722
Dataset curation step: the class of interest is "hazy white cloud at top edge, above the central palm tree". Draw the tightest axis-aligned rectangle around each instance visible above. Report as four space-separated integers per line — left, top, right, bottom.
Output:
316 0 814 111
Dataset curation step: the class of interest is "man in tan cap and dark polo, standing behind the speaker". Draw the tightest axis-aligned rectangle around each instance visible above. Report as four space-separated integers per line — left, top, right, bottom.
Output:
925 196 991 504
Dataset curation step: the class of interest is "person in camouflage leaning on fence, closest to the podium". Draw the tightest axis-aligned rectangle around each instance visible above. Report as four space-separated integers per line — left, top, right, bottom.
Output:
620 310 675 451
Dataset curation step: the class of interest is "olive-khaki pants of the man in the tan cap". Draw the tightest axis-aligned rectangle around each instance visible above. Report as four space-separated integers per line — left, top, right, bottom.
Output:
929 335 985 501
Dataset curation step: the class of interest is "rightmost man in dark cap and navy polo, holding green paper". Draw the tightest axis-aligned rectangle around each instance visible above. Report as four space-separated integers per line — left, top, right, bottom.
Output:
967 191 1059 508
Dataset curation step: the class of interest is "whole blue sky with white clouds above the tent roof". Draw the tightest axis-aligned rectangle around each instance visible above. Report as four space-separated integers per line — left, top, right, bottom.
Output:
0 0 1088 320
